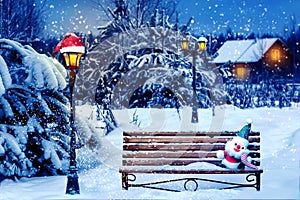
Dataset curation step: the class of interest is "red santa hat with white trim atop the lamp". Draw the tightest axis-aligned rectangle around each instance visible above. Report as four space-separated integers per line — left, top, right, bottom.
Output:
52 33 85 57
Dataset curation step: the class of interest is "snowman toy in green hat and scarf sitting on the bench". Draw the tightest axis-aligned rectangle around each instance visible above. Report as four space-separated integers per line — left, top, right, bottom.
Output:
217 119 257 169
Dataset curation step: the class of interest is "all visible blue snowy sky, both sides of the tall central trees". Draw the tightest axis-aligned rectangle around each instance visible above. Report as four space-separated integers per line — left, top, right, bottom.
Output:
46 0 300 35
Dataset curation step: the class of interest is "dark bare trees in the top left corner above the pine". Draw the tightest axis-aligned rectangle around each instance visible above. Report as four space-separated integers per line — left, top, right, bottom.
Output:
0 0 44 41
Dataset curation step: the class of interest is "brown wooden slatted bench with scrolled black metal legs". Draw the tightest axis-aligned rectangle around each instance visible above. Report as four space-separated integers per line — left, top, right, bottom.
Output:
119 132 263 191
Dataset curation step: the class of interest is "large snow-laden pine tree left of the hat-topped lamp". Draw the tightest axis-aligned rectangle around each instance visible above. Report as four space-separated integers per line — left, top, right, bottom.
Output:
0 39 69 179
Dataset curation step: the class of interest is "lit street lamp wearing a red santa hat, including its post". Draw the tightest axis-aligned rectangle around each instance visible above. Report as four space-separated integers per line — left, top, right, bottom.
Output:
52 33 85 194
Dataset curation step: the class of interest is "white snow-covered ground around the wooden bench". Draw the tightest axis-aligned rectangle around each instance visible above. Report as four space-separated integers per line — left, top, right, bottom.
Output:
0 105 300 200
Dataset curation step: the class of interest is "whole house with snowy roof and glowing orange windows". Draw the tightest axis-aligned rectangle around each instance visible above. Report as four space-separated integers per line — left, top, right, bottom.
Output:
212 38 293 83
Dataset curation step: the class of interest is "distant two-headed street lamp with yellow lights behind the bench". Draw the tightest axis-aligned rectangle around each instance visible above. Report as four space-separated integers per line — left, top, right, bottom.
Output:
181 36 207 123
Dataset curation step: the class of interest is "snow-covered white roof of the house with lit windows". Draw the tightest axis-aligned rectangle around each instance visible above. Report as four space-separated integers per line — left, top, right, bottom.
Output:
212 38 279 64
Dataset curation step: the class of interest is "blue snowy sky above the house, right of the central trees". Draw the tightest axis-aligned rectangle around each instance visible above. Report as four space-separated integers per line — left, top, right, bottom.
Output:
180 0 300 34
